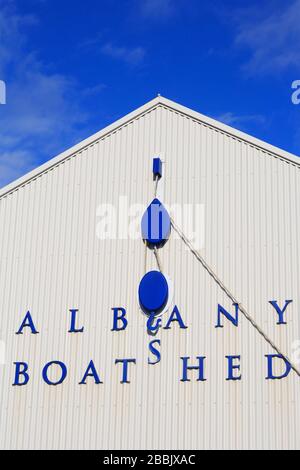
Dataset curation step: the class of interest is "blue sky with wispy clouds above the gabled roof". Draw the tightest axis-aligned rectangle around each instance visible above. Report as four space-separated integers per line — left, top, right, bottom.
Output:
0 0 300 187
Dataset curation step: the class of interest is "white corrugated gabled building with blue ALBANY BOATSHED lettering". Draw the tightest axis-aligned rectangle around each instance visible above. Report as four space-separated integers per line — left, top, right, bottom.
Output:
0 97 300 449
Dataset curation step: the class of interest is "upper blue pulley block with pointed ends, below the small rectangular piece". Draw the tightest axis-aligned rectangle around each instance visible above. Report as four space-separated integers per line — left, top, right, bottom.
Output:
142 199 171 246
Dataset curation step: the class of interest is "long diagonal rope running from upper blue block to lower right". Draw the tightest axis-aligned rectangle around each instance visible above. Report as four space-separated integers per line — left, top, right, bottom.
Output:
171 218 300 377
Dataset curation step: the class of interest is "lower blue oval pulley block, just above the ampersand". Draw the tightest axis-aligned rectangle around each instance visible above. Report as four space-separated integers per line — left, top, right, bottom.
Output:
139 271 169 314
